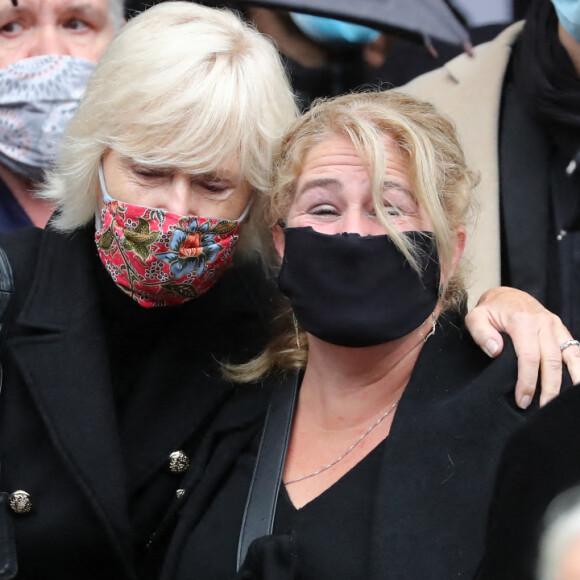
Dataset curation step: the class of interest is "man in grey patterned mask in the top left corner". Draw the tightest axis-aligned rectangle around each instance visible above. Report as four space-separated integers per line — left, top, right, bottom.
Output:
0 0 124 231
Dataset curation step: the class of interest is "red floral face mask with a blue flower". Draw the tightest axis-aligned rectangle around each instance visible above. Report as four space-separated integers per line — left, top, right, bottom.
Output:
95 164 246 308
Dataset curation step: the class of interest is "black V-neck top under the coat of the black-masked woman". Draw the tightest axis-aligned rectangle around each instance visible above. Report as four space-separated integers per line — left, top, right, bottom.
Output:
178 428 385 580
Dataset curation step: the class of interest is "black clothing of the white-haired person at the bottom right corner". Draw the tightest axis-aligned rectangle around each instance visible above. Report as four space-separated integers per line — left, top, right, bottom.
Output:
477 387 580 580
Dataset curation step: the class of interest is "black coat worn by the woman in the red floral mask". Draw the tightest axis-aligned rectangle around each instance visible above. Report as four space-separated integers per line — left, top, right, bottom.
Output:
0 228 269 580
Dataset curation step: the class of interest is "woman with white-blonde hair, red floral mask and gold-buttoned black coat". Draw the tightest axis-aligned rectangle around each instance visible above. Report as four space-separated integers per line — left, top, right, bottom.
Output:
0 2 296 580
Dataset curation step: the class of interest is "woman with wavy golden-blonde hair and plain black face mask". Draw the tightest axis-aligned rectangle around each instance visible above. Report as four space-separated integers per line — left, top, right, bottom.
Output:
161 91 536 580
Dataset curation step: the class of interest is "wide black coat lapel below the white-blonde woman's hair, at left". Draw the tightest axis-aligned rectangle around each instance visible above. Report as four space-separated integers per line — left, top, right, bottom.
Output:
5 231 130 563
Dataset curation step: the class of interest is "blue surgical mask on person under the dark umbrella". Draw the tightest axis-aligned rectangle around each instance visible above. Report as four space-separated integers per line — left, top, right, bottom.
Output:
290 12 380 44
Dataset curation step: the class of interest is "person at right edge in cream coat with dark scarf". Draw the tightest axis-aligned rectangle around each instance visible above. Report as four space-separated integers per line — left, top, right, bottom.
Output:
404 0 580 372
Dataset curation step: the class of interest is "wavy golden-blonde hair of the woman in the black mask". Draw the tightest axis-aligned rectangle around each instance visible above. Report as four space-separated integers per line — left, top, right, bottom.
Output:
228 91 477 381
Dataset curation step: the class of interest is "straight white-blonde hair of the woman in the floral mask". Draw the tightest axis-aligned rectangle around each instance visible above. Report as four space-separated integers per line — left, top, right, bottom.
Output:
41 2 297 258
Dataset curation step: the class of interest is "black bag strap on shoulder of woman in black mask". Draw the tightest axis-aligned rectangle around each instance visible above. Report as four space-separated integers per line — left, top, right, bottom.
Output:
237 373 300 570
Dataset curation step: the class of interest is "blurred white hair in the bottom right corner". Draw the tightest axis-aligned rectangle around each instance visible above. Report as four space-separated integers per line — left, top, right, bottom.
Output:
537 487 580 580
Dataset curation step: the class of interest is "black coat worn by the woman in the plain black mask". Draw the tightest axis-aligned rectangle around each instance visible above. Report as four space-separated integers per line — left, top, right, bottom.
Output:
162 314 525 580
